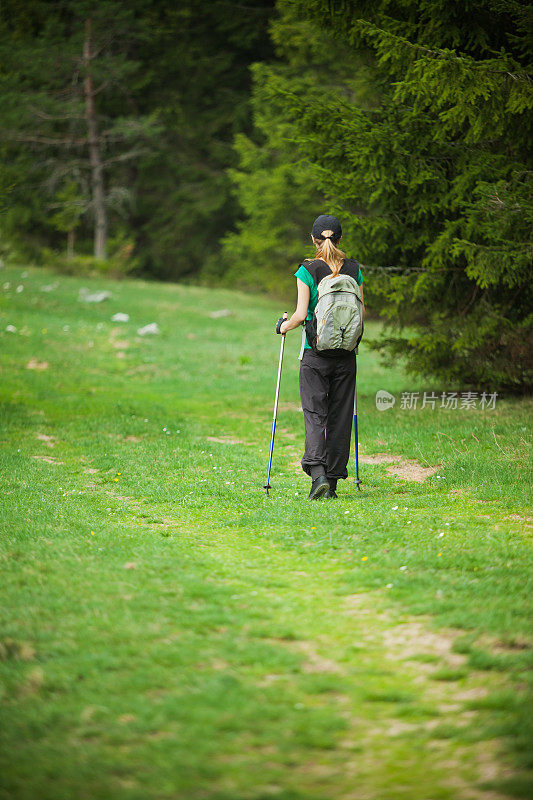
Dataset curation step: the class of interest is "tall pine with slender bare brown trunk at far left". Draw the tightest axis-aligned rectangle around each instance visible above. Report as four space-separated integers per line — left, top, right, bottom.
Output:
1 0 157 259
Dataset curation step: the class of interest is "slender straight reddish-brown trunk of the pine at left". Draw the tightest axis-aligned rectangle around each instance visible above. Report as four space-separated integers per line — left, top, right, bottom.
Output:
83 19 107 259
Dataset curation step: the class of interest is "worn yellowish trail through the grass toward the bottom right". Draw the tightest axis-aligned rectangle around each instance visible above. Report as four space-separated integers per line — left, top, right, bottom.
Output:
47 460 512 800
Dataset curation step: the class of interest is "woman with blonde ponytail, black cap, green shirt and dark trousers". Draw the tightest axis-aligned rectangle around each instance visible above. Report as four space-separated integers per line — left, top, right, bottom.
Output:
276 214 364 500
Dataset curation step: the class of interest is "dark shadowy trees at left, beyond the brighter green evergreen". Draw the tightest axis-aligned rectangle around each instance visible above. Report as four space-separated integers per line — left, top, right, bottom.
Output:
0 0 273 279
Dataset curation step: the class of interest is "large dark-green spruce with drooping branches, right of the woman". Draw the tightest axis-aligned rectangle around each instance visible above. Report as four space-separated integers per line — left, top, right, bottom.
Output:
264 0 533 391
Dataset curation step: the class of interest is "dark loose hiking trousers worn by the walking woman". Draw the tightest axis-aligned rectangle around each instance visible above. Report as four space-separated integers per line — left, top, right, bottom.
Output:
300 350 356 479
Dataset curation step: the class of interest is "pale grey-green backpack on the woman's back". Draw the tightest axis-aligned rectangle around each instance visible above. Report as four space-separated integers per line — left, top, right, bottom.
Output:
305 275 363 356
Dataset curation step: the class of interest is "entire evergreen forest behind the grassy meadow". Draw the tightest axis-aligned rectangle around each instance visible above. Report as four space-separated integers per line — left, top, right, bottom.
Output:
0 0 533 394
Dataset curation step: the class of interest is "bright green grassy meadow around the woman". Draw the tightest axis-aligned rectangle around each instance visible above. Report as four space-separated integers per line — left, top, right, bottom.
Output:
0 267 533 800
